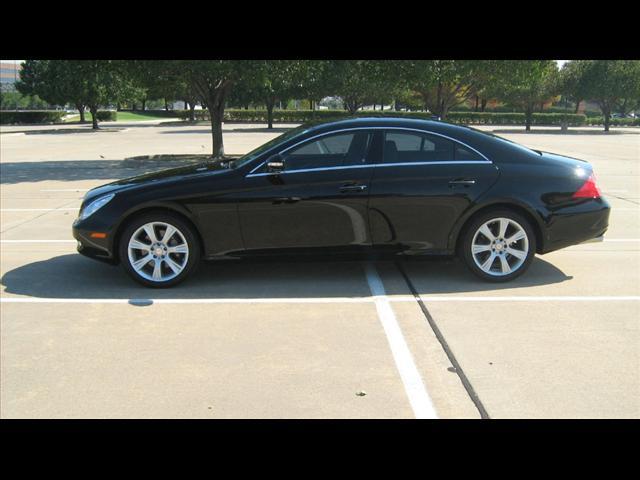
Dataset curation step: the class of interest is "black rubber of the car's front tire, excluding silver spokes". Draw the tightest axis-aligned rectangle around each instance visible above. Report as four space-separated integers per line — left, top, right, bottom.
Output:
118 212 200 288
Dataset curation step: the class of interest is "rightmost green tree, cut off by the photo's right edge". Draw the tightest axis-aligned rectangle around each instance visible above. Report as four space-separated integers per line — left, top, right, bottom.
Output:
581 60 640 132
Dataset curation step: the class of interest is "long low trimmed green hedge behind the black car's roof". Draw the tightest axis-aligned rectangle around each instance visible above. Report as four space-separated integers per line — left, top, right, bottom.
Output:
175 109 586 126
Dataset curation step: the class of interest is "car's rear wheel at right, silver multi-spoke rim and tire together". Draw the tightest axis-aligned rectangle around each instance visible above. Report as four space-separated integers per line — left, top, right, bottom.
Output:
460 209 536 282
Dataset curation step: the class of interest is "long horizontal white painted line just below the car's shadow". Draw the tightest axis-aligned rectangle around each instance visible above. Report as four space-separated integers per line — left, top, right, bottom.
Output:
0 294 640 305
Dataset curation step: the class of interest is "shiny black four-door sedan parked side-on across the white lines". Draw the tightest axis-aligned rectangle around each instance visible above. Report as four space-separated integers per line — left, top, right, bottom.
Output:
73 118 610 287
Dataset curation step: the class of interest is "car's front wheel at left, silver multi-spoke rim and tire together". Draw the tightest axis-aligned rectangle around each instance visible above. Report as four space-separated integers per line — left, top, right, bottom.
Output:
118 212 200 288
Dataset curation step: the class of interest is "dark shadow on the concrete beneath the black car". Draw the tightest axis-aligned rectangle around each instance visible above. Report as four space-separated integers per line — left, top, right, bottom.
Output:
1 254 572 299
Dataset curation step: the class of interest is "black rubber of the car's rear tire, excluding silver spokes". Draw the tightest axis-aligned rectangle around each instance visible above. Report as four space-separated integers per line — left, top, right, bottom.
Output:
459 208 536 282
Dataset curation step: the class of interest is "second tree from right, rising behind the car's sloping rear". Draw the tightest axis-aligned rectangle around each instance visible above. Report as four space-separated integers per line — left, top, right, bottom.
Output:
496 60 558 131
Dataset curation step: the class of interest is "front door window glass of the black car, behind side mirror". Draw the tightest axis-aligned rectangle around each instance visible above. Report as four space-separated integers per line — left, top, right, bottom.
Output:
284 131 371 171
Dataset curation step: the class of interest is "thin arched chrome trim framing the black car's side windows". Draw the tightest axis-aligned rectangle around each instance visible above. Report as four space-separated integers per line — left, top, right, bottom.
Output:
245 127 493 178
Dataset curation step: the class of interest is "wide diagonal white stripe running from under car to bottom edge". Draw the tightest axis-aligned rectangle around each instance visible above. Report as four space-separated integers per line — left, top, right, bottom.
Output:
366 263 438 419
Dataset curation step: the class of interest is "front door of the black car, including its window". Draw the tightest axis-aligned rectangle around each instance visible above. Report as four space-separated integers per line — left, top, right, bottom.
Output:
238 130 373 253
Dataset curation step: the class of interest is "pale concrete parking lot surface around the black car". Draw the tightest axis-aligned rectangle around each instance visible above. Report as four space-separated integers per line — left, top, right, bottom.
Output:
0 122 640 418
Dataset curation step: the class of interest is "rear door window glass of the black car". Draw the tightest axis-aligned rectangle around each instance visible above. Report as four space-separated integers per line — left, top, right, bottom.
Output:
383 132 454 163
